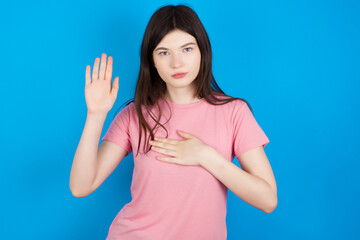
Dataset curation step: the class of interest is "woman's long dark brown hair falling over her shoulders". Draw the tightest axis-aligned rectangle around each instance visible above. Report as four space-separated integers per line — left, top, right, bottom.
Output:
113 5 253 158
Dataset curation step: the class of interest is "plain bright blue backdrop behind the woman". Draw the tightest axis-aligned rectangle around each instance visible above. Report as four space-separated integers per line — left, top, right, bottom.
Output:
0 0 360 240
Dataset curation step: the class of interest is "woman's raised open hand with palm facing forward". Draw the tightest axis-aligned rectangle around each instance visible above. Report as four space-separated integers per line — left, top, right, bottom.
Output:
85 53 119 115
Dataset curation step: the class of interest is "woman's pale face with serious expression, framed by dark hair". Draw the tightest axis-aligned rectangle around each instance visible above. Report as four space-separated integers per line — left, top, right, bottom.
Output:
153 29 201 94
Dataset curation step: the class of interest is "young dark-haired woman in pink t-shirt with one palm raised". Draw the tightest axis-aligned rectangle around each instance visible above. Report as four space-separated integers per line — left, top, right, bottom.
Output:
70 5 277 240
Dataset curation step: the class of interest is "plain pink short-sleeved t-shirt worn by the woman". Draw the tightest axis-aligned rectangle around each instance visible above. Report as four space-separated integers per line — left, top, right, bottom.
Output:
102 98 269 240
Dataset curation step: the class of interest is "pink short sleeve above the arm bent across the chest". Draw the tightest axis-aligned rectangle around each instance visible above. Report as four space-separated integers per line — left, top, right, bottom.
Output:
232 100 270 157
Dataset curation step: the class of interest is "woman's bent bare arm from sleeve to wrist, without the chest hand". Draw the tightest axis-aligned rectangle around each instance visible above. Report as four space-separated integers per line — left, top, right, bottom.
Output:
200 146 277 213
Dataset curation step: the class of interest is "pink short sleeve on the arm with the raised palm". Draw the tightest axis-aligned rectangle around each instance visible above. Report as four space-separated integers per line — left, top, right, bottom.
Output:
102 103 132 156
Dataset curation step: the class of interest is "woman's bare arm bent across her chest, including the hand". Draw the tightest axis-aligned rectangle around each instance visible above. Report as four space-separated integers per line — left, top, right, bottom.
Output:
149 130 277 213
